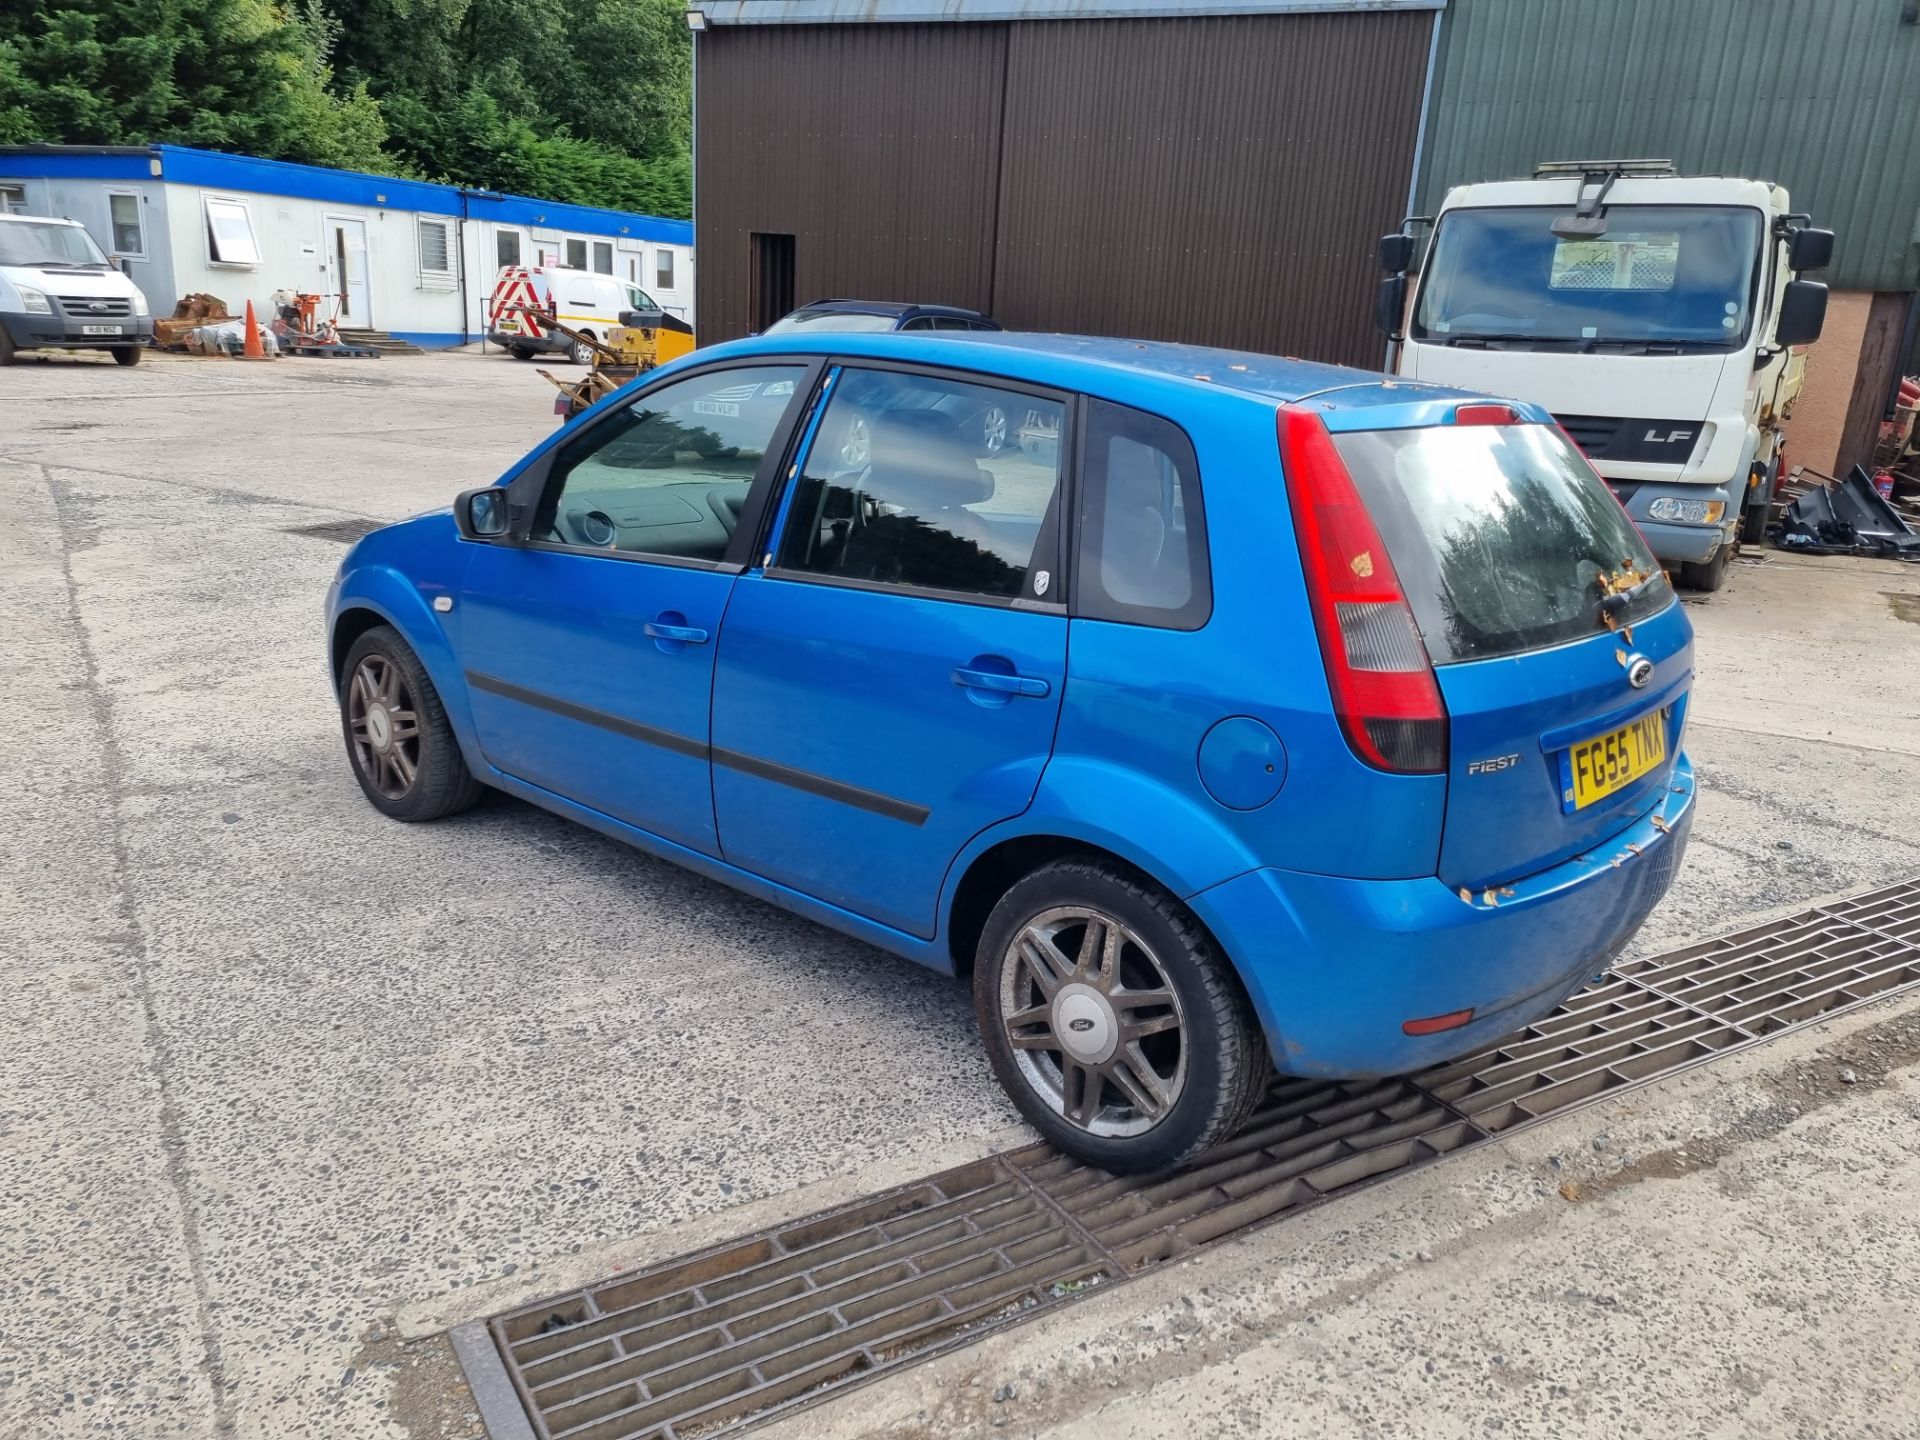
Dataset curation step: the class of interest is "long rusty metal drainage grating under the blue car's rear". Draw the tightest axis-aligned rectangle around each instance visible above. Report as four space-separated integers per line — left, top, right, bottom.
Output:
476 881 1920 1440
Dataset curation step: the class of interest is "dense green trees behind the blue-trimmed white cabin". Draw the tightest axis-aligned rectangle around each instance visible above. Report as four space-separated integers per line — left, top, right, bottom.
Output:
0 0 693 217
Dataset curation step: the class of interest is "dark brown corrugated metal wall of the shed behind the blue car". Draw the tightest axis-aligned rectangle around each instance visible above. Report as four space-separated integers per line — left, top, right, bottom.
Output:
695 12 1434 367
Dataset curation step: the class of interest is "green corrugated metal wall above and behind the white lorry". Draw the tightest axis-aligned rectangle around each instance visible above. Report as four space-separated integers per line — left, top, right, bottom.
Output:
1419 0 1920 290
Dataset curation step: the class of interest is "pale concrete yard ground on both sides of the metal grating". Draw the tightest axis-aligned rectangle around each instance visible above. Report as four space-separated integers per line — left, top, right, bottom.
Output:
0 343 1920 1440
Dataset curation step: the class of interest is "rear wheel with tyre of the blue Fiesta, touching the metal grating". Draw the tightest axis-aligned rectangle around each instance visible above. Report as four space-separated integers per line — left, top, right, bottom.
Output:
973 860 1273 1173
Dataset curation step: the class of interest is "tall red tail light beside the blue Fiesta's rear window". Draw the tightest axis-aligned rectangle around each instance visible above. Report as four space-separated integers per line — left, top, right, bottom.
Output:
1281 409 1448 774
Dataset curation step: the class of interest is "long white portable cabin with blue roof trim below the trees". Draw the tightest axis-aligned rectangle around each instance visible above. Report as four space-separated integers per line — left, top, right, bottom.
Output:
0 144 693 349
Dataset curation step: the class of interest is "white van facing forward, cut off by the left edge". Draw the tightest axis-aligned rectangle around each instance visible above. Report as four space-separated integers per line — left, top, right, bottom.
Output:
0 215 154 365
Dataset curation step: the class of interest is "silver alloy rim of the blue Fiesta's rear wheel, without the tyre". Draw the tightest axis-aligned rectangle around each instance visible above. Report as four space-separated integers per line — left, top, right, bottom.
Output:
1000 906 1187 1137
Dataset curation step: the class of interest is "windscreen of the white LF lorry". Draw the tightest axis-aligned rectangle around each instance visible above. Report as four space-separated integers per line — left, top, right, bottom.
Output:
1411 205 1761 348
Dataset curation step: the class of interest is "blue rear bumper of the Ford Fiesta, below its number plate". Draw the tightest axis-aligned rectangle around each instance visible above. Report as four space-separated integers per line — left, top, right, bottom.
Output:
1188 755 1693 1079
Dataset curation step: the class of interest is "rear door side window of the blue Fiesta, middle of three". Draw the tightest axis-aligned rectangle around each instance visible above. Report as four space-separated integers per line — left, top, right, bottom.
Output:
778 369 1064 601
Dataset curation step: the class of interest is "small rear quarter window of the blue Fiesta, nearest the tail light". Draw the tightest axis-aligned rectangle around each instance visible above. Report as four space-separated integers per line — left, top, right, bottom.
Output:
1073 399 1213 630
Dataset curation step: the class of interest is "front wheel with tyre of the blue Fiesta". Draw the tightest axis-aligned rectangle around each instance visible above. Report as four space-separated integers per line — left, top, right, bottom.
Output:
340 626 486 822
